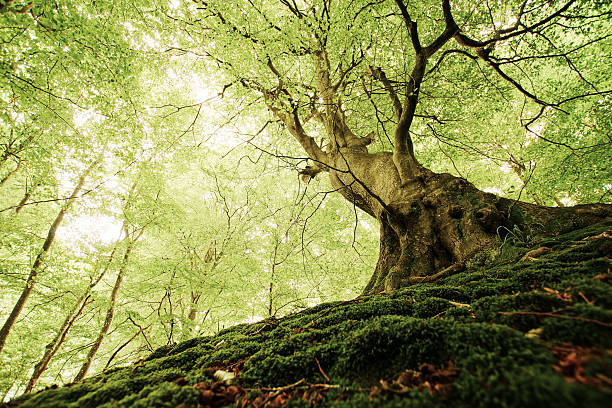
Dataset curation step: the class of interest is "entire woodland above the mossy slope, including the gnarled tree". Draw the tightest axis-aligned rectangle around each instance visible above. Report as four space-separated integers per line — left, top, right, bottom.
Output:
0 0 612 399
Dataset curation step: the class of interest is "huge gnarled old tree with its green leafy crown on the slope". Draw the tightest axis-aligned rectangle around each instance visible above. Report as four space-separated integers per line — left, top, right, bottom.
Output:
165 0 612 293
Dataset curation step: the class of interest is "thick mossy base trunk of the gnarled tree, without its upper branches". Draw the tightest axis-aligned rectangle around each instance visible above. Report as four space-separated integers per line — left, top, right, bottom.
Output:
330 150 612 294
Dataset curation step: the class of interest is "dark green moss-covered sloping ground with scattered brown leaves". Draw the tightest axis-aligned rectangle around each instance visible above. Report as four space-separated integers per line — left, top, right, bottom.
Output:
7 222 612 408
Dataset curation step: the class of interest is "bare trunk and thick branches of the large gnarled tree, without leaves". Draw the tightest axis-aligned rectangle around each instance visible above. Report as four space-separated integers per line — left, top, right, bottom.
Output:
237 0 612 293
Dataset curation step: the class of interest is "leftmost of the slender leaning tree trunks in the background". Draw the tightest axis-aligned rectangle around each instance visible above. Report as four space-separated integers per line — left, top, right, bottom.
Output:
0 159 100 352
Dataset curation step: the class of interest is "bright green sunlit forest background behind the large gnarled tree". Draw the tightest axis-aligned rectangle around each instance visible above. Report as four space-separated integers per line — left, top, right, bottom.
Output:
0 1 612 400
